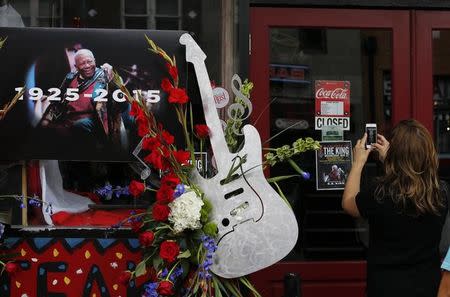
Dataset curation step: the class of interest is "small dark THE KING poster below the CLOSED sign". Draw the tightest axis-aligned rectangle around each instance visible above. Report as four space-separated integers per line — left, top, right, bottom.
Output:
316 141 352 190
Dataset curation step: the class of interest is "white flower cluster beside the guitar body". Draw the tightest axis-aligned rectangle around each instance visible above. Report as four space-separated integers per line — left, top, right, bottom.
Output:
169 191 203 233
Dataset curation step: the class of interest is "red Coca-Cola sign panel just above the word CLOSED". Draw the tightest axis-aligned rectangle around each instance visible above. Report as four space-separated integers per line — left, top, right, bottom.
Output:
315 80 350 117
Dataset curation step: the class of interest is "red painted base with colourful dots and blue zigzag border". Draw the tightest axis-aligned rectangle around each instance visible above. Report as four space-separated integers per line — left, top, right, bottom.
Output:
0 237 145 297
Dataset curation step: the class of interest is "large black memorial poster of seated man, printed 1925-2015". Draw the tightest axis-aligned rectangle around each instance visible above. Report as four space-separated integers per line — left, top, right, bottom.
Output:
0 28 187 161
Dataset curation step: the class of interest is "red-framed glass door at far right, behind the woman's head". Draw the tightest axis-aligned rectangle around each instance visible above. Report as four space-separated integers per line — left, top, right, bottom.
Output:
413 11 450 169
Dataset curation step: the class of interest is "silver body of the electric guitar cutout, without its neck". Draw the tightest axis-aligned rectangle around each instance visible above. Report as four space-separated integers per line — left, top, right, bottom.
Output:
193 125 298 278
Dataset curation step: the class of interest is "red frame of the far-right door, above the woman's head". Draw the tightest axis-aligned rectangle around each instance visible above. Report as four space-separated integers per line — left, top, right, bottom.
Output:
412 11 450 135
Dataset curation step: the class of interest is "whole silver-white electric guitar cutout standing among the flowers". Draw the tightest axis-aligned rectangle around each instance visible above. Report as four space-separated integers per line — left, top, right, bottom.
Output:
180 33 298 278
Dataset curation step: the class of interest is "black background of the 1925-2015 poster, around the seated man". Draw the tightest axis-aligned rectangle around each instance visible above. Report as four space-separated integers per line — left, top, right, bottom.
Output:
0 28 187 161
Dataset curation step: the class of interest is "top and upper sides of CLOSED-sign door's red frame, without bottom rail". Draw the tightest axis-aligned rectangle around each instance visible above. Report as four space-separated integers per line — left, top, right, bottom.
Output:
250 7 412 141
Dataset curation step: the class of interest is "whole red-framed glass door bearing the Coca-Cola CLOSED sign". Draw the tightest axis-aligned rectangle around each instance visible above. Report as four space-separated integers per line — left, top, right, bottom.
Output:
250 8 411 297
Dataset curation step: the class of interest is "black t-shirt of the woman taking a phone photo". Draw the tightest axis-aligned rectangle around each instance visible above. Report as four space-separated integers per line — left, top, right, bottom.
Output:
356 184 447 297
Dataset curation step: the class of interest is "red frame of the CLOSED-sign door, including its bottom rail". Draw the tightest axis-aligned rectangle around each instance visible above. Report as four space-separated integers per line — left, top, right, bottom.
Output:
250 7 412 297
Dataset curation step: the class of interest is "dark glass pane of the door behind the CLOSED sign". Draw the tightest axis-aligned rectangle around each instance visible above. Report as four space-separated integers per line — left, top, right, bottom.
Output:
270 28 392 259
